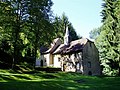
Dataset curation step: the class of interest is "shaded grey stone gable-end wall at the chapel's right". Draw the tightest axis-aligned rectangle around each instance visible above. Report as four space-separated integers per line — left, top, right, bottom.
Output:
83 42 101 75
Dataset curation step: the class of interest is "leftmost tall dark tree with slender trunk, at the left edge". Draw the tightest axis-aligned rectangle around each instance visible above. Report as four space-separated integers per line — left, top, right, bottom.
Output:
0 0 22 67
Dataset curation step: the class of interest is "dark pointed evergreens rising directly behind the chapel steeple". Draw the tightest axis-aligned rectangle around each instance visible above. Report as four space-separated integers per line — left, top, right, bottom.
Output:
53 13 79 41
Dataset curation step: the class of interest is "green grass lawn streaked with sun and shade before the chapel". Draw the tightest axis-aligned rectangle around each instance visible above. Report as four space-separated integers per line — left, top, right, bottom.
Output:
0 70 120 90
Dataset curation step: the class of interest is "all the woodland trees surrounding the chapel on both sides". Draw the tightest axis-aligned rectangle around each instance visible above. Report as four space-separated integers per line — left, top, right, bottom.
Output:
0 0 120 76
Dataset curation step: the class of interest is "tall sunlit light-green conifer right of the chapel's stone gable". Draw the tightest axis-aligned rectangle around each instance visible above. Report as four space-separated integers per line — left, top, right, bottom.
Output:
95 0 120 76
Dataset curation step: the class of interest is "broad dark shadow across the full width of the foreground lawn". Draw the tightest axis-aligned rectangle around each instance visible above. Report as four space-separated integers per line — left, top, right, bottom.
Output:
0 79 120 90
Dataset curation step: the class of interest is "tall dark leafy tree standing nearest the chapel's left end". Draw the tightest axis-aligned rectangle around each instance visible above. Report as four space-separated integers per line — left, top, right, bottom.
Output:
28 0 52 63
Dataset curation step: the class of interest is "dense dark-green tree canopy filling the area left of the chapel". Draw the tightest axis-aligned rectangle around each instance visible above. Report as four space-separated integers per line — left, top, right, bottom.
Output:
0 0 52 66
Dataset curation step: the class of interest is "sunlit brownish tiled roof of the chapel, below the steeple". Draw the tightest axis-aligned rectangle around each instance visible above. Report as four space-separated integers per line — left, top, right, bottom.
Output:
40 38 90 54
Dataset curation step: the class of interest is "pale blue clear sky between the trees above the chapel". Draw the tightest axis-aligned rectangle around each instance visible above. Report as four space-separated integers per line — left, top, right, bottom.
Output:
52 0 102 38
